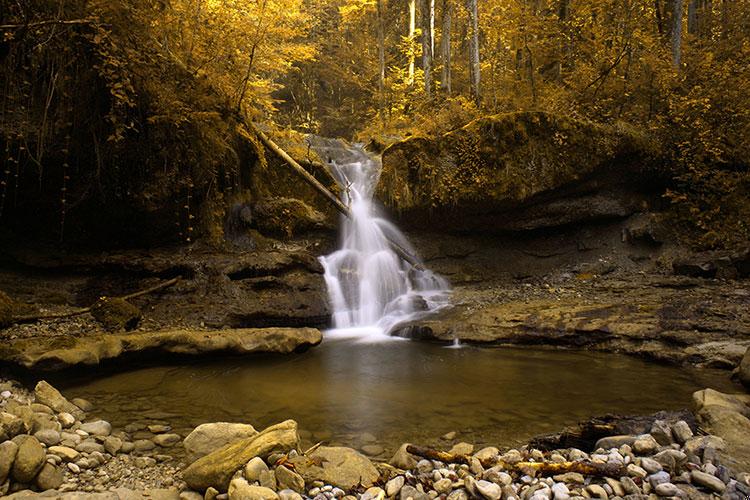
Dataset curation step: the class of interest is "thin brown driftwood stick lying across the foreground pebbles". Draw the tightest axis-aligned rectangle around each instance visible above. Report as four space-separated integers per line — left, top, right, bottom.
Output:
406 445 624 478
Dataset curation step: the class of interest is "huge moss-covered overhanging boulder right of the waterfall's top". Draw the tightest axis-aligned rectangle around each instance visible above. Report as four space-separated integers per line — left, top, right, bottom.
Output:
378 112 659 231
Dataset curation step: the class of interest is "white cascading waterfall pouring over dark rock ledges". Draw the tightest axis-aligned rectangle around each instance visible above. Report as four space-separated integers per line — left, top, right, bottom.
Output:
316 138 449 339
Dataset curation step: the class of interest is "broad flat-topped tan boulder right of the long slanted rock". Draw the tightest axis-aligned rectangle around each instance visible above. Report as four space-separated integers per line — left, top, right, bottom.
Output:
292 446 380 490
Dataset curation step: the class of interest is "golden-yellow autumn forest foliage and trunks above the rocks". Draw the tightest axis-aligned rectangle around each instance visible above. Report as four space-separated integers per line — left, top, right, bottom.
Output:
0 0 750 247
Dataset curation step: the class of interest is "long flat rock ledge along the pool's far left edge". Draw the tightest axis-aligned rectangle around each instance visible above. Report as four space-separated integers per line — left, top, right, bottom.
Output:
0 328 323 371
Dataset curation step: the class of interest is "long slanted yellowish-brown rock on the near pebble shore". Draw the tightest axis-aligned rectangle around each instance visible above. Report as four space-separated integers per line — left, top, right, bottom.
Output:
182 420 299 491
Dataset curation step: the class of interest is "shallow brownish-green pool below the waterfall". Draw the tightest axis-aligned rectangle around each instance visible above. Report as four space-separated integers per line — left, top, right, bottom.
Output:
51 335 737 458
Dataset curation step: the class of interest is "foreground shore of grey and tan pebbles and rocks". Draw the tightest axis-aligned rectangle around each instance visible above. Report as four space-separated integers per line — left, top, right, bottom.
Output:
0 380 750 500
